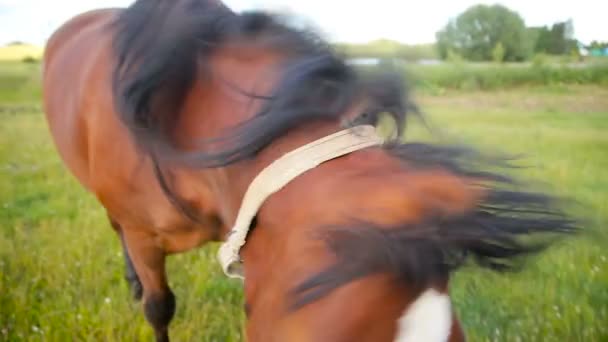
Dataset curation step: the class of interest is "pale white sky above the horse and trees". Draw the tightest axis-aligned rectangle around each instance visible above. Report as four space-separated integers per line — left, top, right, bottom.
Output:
0 0 608 45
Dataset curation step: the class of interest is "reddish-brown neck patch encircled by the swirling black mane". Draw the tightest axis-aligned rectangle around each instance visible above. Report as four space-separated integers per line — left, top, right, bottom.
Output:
175 47 278 146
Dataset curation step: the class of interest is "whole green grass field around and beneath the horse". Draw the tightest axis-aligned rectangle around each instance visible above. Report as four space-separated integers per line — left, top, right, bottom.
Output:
0 64 608 341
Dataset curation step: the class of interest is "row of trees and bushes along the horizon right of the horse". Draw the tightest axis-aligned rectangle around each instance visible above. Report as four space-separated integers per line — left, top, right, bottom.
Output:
337 5 608 62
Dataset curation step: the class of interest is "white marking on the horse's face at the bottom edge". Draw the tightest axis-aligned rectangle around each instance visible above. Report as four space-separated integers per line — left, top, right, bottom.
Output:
395 289 452 342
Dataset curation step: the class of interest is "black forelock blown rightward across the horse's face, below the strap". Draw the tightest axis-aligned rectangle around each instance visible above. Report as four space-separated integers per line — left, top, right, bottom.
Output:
291 143 579 310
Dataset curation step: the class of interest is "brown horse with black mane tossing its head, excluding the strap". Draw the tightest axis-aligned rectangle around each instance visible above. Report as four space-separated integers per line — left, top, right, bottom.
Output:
44 0 575 342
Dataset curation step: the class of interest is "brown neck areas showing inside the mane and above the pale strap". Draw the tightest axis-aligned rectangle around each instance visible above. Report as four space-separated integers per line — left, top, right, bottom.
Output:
169 49 337 225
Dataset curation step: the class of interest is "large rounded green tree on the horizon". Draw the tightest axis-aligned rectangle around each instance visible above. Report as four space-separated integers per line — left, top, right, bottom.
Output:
437 5 533 61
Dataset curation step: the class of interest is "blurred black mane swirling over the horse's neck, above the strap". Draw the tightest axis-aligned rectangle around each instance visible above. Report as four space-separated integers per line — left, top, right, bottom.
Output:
114 0 408 167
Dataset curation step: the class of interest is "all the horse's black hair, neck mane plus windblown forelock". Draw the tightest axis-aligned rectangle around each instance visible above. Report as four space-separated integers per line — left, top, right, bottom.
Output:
114 0 575 308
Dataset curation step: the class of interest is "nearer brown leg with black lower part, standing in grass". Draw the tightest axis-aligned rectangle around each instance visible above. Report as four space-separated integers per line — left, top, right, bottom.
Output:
123 227 175 342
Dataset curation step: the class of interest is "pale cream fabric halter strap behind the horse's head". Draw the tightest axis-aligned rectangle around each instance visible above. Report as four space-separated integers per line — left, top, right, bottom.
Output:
218 125 384 279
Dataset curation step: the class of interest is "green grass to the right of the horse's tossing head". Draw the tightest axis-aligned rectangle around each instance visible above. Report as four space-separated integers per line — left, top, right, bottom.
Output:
416 87 608 341
